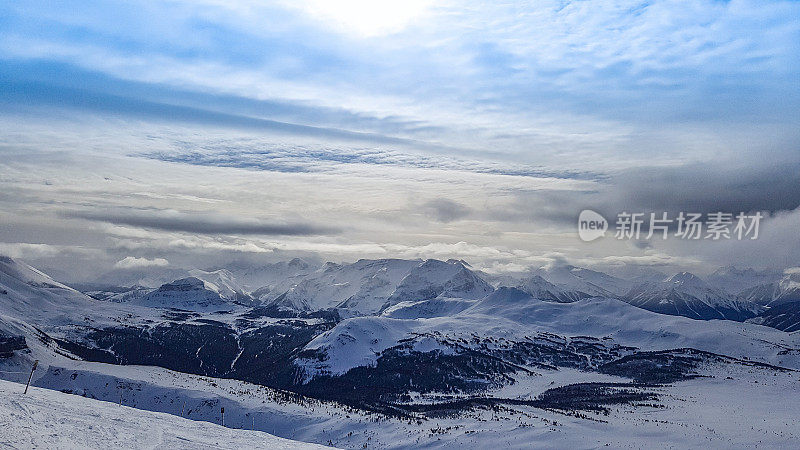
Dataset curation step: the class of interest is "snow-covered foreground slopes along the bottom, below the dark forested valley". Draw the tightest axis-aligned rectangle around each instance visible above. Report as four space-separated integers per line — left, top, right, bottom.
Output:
0 354 800 449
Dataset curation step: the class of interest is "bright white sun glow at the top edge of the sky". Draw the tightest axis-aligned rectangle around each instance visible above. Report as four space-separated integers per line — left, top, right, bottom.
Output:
293 0 432 37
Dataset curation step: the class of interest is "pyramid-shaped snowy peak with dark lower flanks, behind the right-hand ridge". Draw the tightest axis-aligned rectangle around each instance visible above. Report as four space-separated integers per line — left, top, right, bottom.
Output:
623 272 763 321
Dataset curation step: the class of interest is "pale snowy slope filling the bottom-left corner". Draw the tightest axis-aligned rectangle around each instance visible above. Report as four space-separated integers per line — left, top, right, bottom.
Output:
0 381 332 449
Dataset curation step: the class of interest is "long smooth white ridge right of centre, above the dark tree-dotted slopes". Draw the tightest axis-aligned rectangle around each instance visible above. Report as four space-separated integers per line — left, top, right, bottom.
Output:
297 287 800 382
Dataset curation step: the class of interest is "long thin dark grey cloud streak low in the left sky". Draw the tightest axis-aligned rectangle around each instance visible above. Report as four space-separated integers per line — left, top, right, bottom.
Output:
61 210 339 236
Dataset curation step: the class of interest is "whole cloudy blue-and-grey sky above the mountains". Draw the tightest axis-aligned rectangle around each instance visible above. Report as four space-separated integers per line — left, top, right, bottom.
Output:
0 0 800 280
